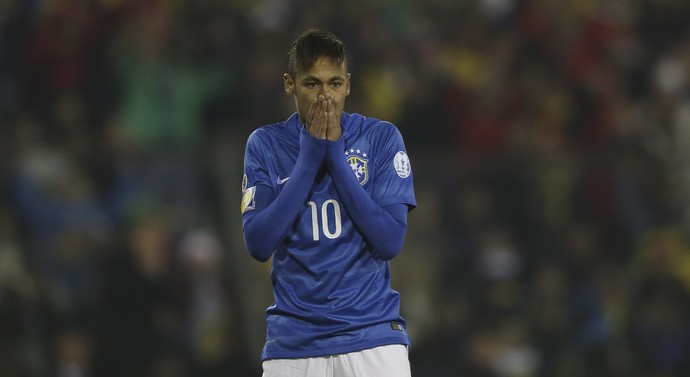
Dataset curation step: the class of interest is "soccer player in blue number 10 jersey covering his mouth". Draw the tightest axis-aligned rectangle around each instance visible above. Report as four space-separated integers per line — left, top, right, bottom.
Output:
241 29 416 377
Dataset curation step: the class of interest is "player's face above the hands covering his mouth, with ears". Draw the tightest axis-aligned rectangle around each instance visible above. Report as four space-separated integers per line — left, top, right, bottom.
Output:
283 58 350 122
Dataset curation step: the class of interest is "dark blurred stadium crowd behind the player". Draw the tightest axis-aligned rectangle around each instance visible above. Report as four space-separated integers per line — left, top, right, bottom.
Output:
0 0 690 377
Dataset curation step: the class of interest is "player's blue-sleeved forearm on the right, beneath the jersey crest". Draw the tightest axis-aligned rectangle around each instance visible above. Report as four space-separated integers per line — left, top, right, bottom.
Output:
326 138 408 260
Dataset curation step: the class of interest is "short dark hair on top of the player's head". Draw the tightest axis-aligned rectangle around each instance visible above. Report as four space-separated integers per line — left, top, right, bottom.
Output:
288 28 347 76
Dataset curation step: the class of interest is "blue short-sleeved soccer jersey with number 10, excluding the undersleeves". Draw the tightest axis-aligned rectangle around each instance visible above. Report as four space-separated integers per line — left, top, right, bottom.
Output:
243 113 416 360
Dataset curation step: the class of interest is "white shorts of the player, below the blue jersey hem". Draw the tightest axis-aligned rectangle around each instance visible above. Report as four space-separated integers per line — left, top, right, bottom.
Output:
262 344 410 377
